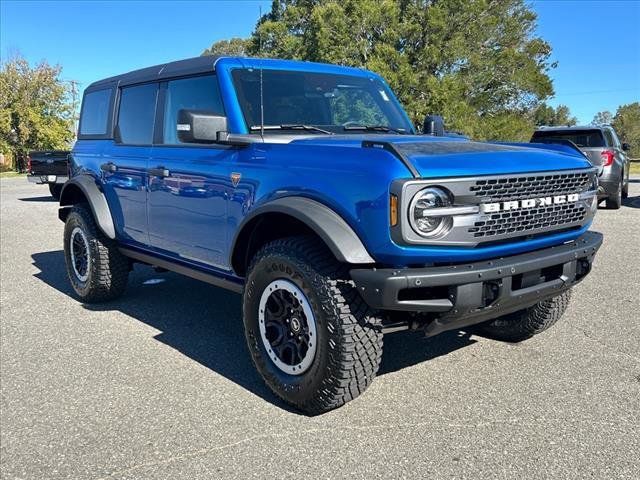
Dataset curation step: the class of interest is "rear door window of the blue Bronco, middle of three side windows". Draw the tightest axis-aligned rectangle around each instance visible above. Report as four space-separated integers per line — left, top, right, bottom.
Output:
118 83 158 145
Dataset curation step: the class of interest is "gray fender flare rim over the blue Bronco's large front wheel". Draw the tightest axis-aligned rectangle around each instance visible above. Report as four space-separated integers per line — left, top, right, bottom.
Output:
230 196 375 264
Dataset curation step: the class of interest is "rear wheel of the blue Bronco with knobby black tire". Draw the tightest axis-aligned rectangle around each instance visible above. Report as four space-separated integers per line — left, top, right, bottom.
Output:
64 204 129 303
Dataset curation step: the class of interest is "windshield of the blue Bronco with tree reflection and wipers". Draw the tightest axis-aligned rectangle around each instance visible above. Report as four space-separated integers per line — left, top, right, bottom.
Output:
232 69 413 134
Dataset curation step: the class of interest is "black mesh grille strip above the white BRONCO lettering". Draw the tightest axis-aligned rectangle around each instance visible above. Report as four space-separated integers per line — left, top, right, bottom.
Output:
470 173 593 201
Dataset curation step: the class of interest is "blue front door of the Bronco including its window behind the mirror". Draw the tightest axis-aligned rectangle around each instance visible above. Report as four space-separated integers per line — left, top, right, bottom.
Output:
148 74 237 270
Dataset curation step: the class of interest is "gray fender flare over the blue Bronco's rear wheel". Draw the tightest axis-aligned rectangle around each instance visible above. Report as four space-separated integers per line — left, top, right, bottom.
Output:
58 175 116 240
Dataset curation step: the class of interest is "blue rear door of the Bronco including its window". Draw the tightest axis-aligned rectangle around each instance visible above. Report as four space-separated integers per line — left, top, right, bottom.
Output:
101 83 158 245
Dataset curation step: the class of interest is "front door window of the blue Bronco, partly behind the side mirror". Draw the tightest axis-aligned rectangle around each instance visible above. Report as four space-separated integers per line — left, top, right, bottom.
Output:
163 75 224 145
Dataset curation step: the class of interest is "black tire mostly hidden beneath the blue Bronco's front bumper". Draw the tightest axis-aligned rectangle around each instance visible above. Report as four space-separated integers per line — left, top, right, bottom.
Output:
477 290 571 343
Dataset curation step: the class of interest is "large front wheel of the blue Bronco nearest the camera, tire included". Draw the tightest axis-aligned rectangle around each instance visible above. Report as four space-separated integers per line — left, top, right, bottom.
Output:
243 236 383 415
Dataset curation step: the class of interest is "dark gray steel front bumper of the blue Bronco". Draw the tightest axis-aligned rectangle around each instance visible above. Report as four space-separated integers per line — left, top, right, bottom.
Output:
351 232 602 335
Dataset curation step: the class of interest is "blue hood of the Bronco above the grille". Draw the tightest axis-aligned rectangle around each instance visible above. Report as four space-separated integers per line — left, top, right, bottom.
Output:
291 135 591 178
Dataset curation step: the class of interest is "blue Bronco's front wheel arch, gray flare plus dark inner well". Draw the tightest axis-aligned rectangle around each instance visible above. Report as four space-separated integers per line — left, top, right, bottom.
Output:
230 197 375 276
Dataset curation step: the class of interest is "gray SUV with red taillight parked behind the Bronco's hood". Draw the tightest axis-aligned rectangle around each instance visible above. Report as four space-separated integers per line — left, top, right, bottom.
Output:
531 125 629 209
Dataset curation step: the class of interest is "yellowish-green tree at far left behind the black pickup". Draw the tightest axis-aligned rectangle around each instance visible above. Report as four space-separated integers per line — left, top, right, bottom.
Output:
0 57 74 170
